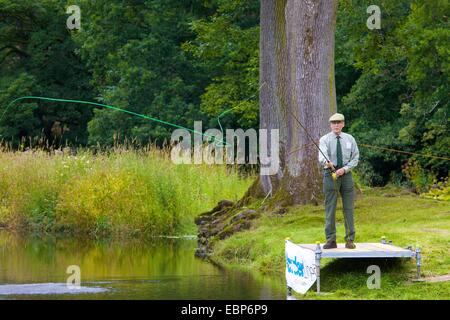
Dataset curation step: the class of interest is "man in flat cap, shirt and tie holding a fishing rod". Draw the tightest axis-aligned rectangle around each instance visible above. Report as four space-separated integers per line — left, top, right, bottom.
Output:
319 113 359 249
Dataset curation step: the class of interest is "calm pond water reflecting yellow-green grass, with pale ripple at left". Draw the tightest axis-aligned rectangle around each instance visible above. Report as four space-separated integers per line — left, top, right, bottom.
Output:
0 230 286 300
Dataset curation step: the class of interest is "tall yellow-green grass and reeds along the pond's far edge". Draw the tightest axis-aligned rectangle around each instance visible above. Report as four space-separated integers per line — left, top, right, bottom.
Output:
0 148 251 236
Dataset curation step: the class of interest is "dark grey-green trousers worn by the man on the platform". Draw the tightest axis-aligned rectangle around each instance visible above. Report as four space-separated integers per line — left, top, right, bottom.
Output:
323 170 355 241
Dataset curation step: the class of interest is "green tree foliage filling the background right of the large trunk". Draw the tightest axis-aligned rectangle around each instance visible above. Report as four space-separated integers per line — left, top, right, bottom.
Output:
336 0 450 185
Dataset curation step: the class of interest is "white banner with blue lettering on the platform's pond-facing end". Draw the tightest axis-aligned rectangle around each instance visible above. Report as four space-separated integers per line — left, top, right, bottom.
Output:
285 240 317 294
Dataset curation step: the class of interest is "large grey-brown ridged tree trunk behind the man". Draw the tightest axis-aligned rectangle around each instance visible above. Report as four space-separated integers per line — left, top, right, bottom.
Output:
259 0 337 205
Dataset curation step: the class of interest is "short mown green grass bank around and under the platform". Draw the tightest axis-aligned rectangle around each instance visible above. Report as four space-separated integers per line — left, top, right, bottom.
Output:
213 188 450 299
